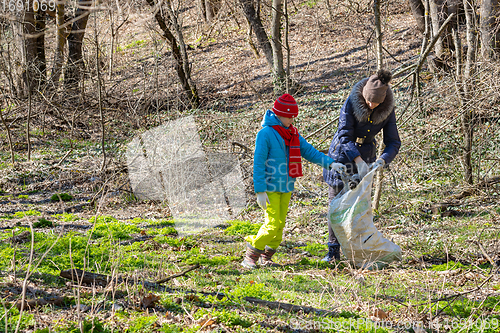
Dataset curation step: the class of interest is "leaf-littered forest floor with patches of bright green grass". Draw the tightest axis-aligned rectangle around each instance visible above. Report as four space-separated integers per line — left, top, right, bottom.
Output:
0 1 500 333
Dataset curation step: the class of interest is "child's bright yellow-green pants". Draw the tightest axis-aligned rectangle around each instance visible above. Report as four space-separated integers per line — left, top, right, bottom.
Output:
245 192 292 250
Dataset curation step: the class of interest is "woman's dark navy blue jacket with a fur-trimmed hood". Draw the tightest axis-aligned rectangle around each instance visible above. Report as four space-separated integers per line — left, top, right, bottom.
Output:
323 79 401 189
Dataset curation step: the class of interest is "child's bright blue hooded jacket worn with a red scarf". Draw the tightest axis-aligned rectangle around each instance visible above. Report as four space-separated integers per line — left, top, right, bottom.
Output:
253 110 334 193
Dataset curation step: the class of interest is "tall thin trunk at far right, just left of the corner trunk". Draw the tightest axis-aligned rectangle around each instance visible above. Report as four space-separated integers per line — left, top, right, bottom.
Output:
461 0 476 184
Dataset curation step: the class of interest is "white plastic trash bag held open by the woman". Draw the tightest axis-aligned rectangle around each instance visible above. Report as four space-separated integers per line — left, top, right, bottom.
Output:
328 167 402 270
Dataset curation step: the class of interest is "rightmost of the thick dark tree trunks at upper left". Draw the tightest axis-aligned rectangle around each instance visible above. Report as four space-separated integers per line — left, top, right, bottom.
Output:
64 0 92 88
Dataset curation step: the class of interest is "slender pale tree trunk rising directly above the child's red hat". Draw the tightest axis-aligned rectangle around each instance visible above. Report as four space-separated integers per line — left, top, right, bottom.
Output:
271 0 285 94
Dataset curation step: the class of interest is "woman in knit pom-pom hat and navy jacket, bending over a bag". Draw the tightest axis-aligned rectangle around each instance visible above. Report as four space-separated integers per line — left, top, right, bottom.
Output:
323 69 401 261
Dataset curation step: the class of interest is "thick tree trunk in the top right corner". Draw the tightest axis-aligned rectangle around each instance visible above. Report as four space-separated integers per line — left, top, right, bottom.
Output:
480 0 498 59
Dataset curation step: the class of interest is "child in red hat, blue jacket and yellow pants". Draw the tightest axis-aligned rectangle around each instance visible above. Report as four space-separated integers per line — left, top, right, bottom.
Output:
241 94 345 268
